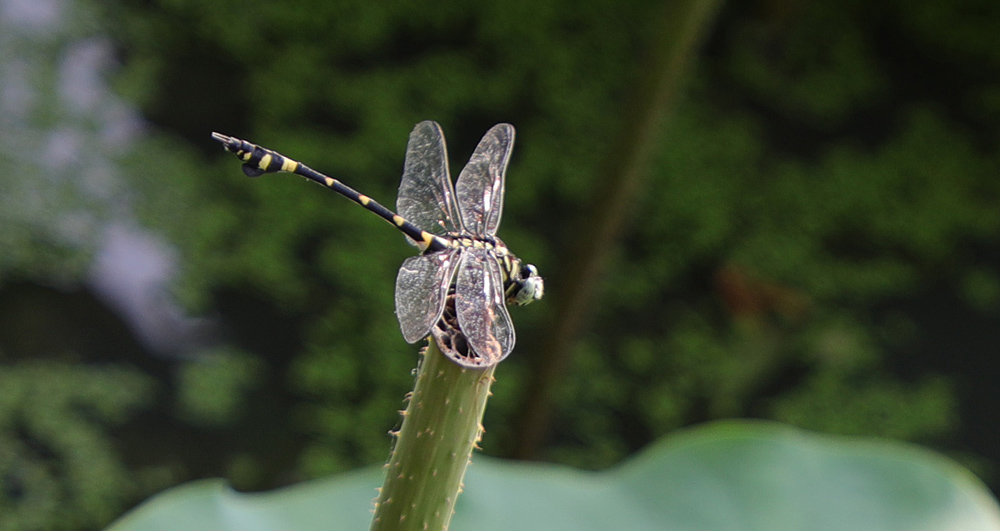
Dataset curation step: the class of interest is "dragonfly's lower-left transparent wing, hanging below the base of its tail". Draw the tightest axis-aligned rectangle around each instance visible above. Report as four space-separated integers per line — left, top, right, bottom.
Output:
396 249 462 343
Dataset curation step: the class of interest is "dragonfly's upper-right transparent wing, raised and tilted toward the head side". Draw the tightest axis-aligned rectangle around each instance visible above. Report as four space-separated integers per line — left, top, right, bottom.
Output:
455 124 514 236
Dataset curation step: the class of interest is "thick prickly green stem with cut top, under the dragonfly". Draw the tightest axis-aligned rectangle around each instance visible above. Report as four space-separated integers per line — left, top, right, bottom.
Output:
371 341 495 531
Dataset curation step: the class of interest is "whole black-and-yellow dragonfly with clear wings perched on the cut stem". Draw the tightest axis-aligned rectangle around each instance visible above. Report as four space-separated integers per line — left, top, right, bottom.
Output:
212 121 545 368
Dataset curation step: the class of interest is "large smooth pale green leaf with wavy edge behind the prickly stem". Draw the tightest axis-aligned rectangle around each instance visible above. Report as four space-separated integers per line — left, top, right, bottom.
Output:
110 421 1000 531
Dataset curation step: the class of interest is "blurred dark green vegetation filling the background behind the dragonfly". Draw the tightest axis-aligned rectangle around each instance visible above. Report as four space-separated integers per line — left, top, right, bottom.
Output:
0 0 1000 529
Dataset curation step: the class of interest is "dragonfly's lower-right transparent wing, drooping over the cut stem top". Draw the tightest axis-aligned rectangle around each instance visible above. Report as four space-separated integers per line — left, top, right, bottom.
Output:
455 249 514 366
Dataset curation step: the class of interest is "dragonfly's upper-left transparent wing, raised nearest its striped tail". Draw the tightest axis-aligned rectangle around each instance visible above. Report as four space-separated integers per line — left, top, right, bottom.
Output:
396 121 461 245
